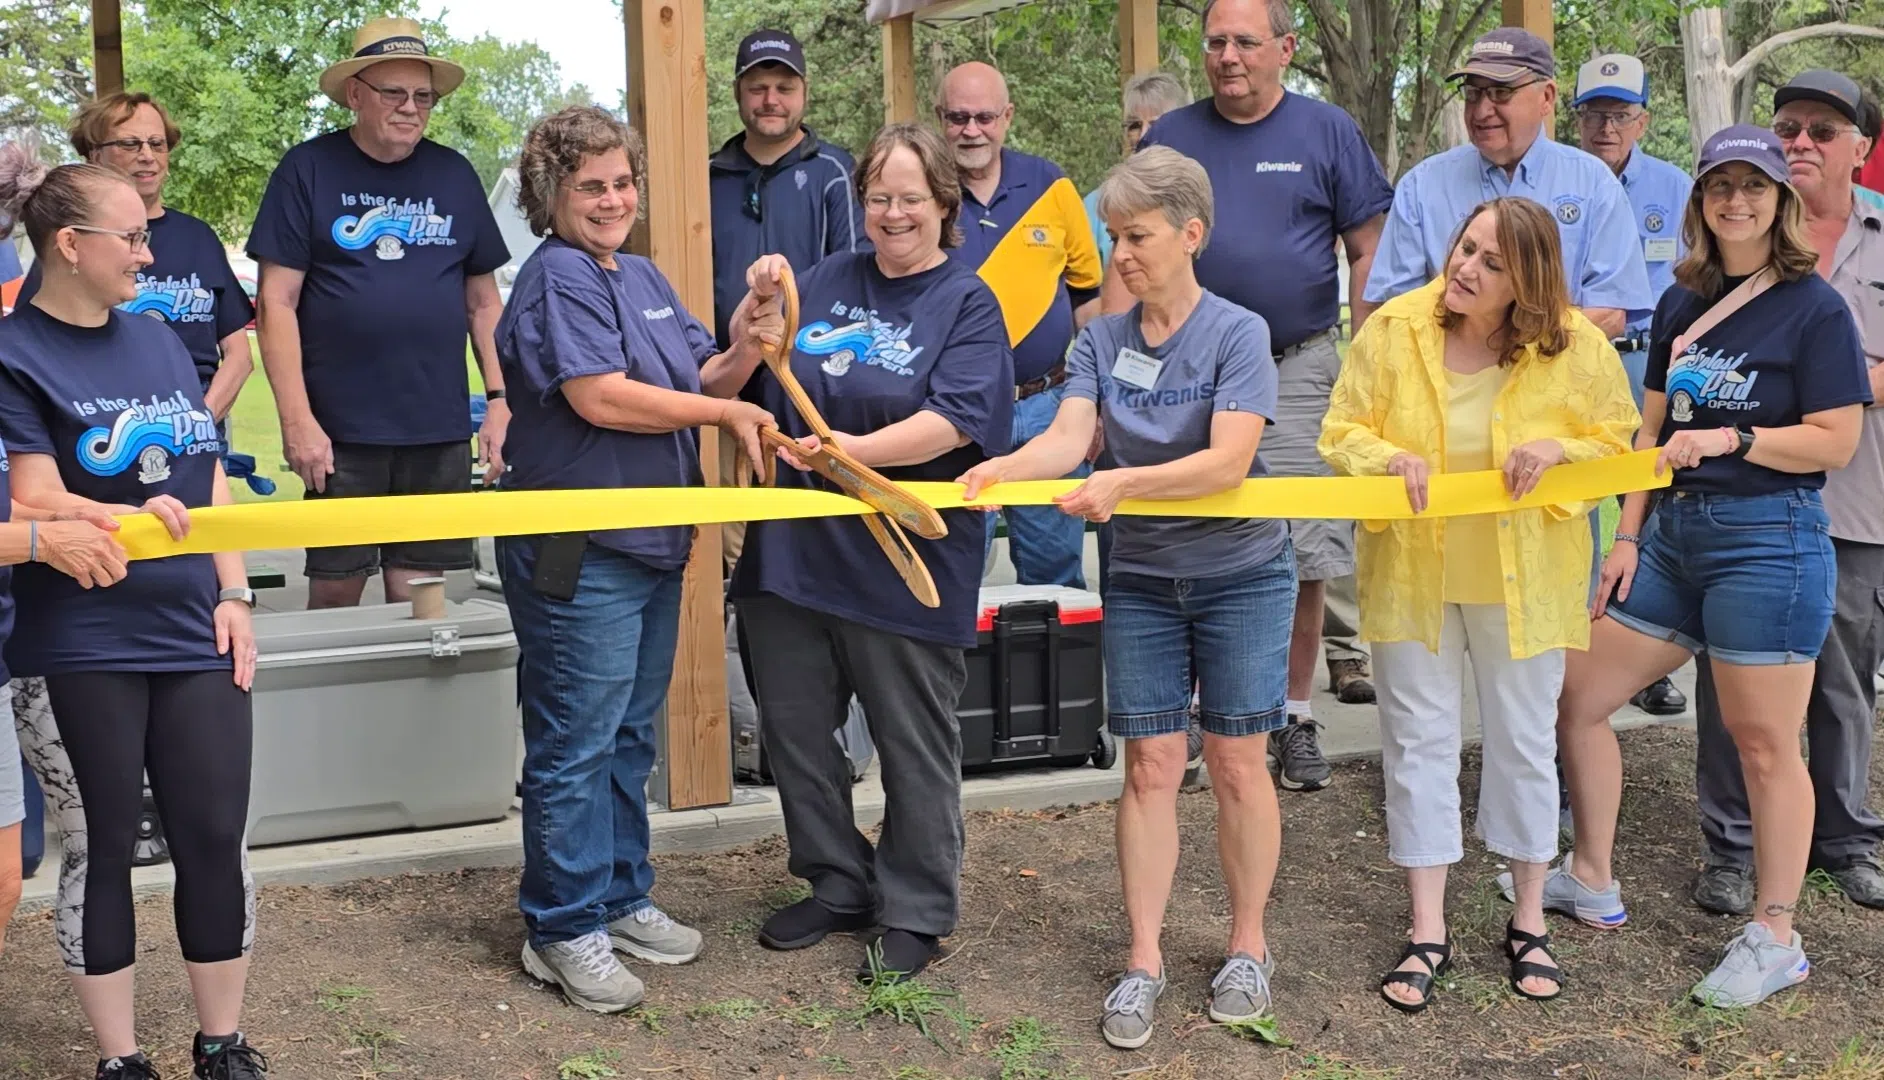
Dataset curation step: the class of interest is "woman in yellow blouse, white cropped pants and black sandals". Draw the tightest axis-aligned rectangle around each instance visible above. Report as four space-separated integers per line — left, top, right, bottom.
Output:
1321 198 1639 1012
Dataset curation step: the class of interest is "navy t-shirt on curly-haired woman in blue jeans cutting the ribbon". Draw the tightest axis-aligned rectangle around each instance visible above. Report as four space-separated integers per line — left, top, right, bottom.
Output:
497 236 718 569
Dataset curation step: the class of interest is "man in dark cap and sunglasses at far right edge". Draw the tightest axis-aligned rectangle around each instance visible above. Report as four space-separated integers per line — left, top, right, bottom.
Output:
1694 70 1884 914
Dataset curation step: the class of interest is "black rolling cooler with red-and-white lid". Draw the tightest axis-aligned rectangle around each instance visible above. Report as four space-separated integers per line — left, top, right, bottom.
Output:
955 584 1115 771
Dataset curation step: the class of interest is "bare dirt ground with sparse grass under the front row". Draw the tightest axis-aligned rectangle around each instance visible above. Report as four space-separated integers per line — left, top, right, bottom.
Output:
0 729 1884 1080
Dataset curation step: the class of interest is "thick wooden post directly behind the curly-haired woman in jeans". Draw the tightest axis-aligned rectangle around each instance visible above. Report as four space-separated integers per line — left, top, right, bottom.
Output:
622 0 733 810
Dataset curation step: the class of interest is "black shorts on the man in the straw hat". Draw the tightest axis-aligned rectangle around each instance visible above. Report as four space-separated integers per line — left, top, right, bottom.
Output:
307 439 473 581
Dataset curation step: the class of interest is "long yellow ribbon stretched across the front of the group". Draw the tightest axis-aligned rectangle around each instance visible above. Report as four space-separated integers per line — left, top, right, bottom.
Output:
119 450 1669 558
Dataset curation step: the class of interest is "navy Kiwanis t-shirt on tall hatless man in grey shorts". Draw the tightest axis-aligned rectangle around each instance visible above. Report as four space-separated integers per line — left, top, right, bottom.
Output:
1138 90 1394 352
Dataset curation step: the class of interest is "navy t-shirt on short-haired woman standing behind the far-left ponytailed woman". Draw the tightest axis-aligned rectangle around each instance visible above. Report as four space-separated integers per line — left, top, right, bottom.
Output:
19 209 254 390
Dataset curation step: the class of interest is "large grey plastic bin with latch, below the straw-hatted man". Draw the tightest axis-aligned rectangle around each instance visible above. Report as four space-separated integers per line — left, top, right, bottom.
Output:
249 597 518 846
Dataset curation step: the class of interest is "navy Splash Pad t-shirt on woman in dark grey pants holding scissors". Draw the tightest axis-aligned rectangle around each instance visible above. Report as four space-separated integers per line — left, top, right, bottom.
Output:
733 253 1014 648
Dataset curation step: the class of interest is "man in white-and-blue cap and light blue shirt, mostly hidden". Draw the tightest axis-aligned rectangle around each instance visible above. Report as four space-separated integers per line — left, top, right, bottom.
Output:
1571 53 1694 716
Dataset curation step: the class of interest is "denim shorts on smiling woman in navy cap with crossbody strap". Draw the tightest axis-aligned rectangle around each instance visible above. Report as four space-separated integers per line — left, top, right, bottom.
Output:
1609 488 1839 667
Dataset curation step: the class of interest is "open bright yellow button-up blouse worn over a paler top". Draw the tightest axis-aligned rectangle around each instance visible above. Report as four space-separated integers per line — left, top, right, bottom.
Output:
1317 279 1641 660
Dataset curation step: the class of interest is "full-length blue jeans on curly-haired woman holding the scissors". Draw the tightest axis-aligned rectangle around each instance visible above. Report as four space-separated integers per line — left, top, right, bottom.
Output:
497 537 682 948
